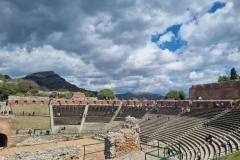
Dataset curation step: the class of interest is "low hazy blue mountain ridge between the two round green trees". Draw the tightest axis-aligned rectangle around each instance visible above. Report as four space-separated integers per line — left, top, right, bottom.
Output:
116 92 164 100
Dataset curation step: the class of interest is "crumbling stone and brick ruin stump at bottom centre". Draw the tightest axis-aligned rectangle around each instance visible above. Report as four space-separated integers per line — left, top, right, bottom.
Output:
104 116 140 158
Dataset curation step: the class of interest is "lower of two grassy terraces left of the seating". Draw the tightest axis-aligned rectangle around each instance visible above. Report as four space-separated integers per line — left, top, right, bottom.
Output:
12 116 51 130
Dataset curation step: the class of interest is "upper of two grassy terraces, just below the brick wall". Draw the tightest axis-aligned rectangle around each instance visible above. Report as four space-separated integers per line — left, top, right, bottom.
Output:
11 105 50 115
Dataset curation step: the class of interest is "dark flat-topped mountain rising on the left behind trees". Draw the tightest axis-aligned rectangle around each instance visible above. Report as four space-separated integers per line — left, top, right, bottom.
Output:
23 71 80 92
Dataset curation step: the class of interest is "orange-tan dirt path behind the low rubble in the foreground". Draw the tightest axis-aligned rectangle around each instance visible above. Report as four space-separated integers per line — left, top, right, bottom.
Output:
0 139 105 160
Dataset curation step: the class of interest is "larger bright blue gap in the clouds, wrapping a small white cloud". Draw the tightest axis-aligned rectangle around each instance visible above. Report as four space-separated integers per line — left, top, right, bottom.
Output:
151 24 187 52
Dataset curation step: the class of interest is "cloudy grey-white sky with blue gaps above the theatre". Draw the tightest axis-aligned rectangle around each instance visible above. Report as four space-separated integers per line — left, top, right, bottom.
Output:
0 0 240 95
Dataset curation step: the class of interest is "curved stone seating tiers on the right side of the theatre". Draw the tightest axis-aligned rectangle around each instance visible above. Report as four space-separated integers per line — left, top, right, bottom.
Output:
140 109 240 160
